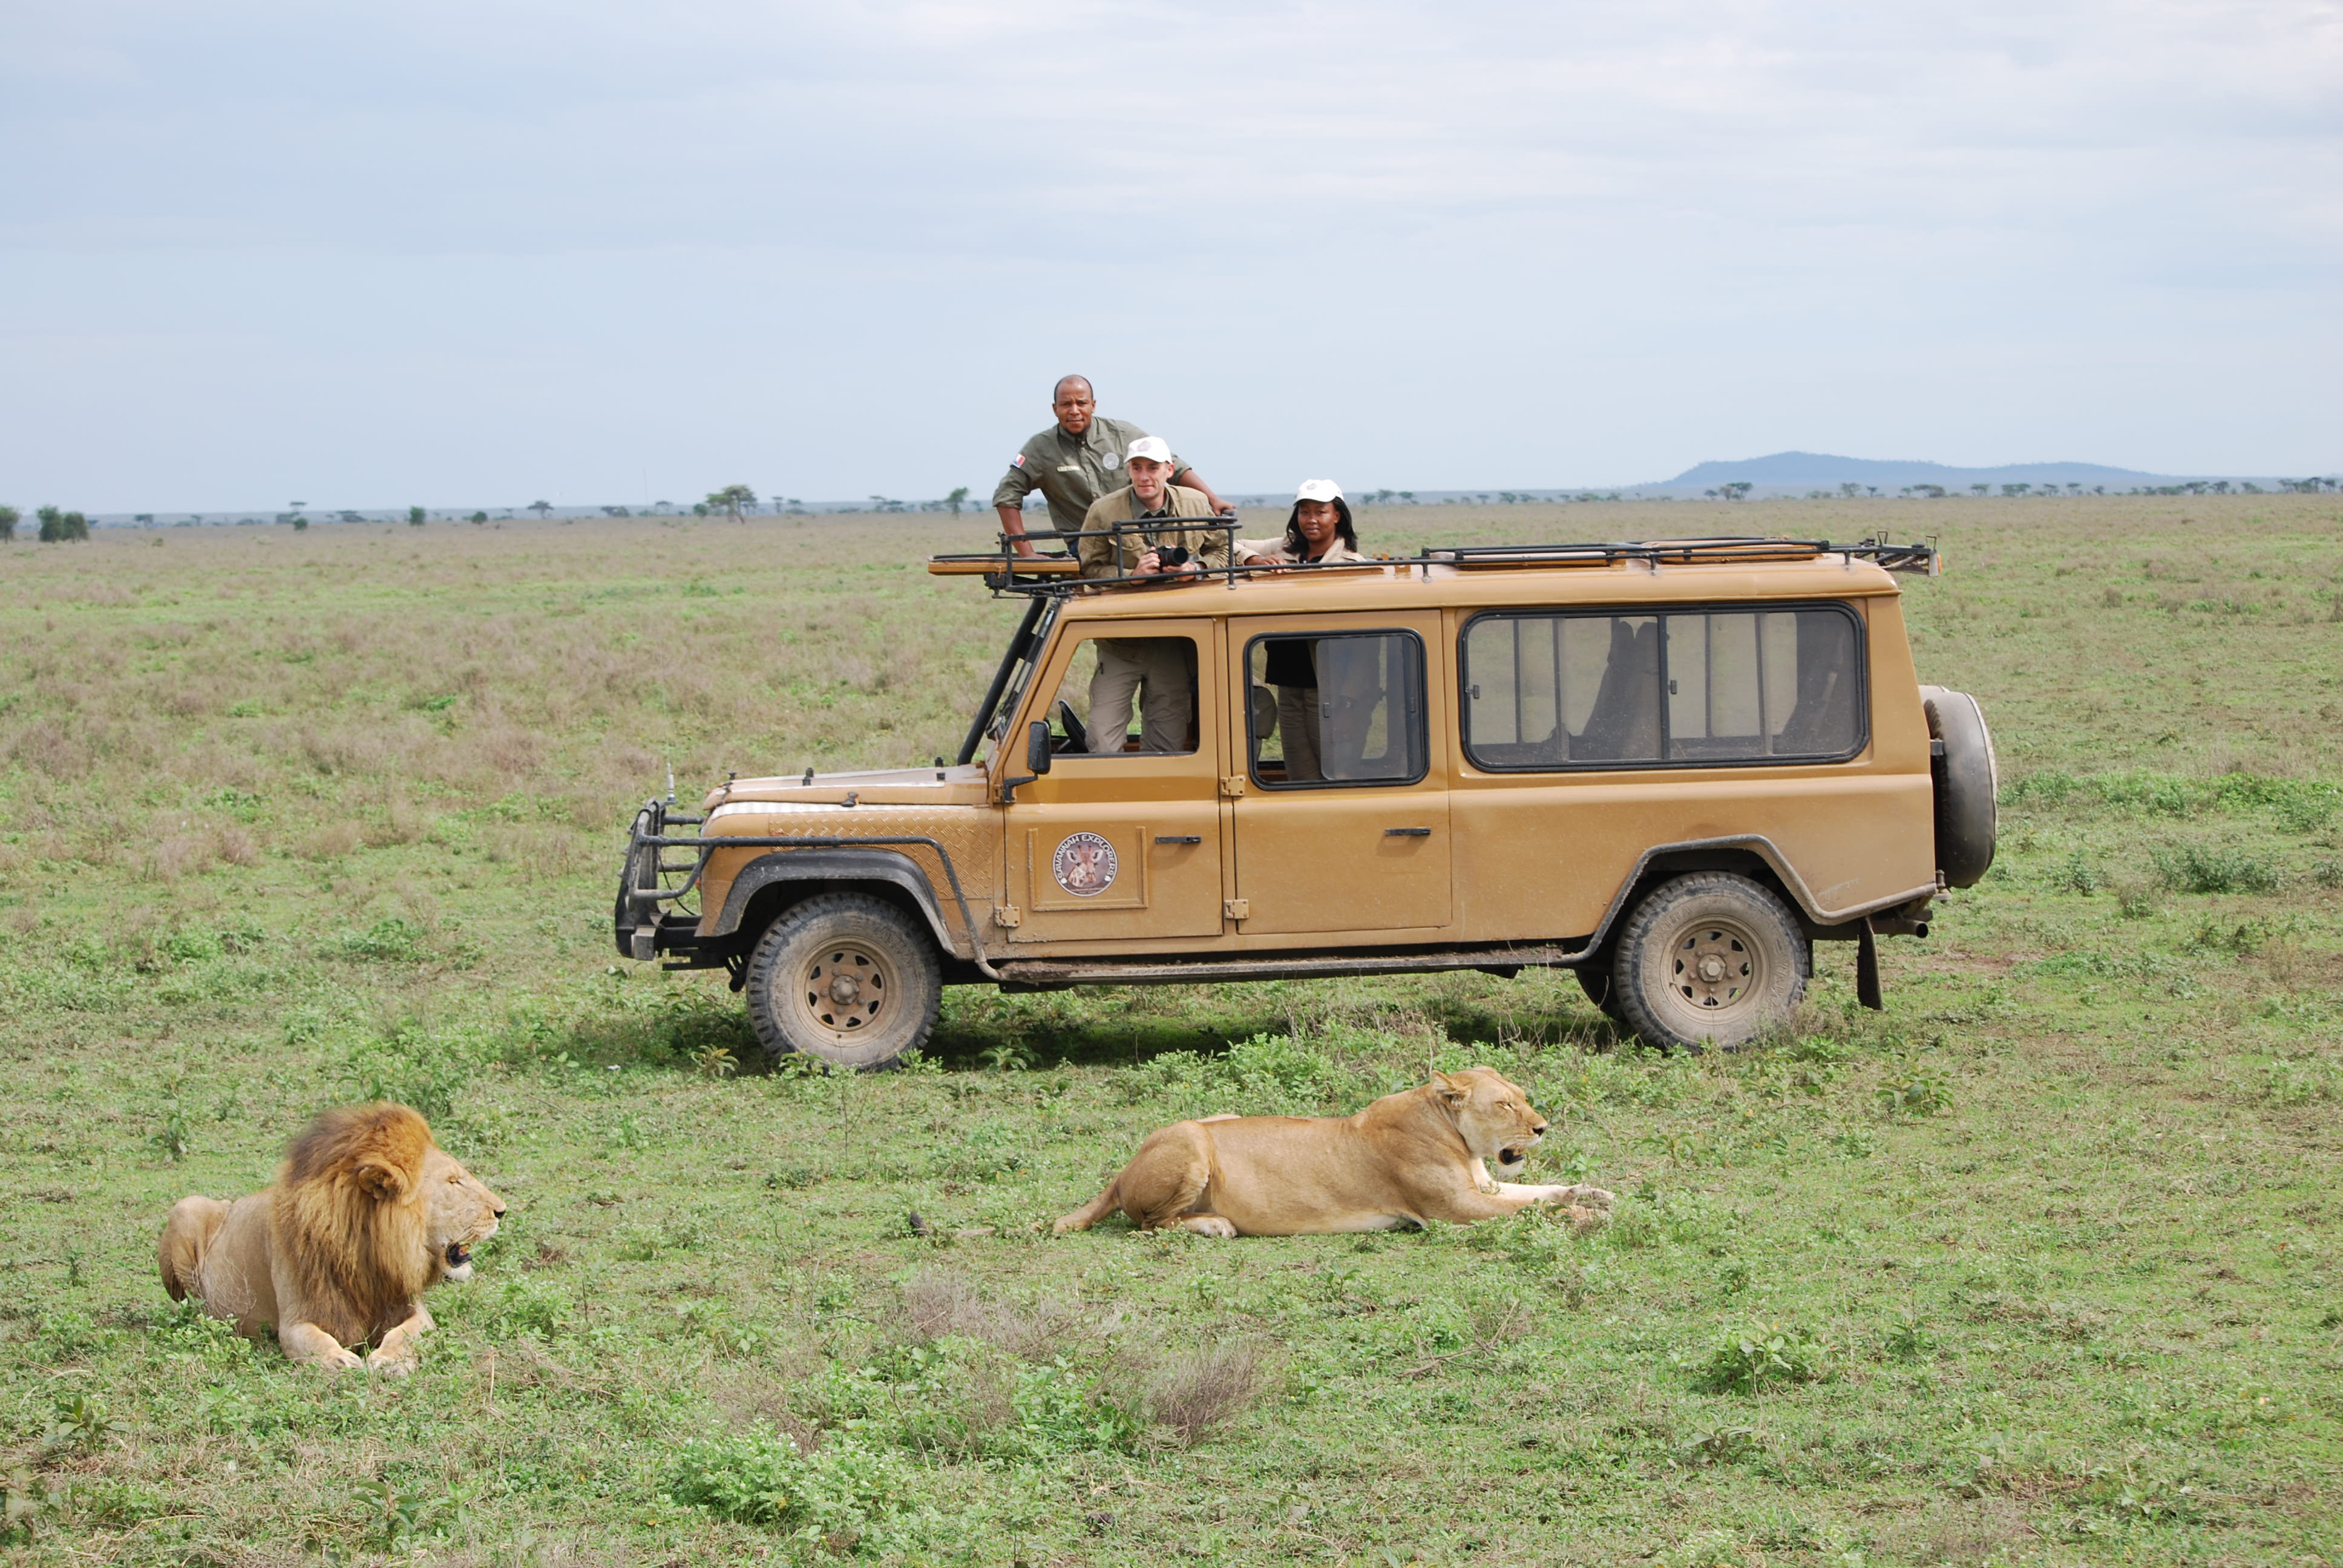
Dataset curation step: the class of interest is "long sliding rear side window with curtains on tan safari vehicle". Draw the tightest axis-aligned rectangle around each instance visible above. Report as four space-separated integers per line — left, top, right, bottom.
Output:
1462 605 1867 771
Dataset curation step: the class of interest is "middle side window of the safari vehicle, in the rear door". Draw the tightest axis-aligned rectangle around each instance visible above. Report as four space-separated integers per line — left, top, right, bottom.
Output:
1244 630 1427 790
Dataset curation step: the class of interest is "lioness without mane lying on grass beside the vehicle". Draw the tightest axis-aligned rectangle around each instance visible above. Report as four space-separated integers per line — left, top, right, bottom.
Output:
1052 1067 1612 1235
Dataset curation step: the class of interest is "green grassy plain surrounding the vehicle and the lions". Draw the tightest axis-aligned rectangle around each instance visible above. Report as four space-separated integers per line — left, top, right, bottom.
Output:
0 497 2343 1568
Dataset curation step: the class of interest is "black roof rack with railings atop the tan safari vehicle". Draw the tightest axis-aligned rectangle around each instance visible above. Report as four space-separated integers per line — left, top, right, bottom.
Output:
928 529 1945 593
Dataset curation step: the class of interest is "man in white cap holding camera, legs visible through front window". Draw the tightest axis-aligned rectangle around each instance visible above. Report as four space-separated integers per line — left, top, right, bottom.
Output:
1075 436 1228 753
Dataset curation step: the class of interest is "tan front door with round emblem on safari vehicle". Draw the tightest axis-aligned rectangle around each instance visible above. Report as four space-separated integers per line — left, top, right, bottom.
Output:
1003 616 1225 942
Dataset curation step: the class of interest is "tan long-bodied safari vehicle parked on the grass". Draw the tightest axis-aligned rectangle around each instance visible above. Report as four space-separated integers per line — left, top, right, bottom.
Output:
616 520 1996 1067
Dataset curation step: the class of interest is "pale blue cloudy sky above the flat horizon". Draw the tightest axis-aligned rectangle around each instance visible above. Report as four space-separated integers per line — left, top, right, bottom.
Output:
0 0 2343 509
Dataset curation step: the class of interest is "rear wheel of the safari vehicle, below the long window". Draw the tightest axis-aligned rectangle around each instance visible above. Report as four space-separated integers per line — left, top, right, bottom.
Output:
1612 872 1814 1050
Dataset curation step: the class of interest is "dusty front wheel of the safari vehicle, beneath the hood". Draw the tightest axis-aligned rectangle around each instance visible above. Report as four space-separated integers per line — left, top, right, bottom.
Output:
742 893 944 1069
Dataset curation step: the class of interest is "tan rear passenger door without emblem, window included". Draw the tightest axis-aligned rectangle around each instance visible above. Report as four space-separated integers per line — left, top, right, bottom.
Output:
1228 609 1450 928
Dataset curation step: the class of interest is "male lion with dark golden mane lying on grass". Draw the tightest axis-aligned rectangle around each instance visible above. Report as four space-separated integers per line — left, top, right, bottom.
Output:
159 1102 503 1376
